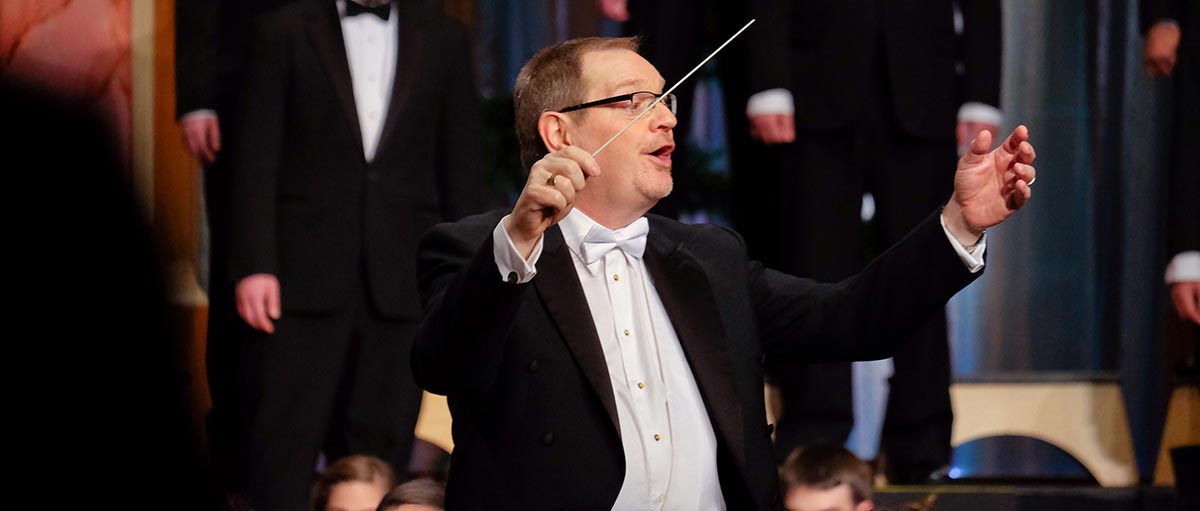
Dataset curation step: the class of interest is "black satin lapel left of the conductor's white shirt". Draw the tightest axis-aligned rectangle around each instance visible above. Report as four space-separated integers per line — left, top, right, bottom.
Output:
533 226 620 434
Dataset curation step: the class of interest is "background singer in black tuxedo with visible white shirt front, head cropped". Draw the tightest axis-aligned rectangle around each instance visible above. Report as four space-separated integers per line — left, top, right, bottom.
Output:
233 0 482 511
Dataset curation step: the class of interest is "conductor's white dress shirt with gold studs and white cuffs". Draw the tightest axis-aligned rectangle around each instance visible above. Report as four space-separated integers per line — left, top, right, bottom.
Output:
492 209 986 511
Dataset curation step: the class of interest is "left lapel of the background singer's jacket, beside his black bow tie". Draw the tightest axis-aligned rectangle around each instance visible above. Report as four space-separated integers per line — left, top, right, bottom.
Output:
307 1 362 155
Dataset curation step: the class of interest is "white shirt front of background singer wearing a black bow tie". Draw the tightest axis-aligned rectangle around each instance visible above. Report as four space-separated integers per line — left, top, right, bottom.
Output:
337 0 400 162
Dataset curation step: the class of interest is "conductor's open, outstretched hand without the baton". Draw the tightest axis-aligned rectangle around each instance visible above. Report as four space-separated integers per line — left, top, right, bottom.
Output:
942 125 1037 245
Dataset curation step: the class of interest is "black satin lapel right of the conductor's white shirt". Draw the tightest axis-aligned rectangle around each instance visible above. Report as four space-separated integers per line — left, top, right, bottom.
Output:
643 223 745 469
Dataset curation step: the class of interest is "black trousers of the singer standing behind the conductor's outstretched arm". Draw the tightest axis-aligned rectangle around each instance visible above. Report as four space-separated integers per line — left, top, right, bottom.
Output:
758 48 956 474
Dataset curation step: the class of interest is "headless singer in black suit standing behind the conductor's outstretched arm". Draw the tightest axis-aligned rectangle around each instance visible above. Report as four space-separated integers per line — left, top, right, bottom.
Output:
734 0 1001 483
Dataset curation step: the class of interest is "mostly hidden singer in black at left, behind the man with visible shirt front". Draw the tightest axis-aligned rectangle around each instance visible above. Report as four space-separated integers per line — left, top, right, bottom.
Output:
175 0 294 499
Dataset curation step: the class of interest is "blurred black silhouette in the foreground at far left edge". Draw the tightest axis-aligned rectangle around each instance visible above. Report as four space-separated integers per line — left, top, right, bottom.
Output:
0 77 214 511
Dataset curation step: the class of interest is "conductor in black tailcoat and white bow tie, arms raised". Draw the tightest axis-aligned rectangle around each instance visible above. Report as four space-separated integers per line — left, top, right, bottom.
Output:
413 37 1034 510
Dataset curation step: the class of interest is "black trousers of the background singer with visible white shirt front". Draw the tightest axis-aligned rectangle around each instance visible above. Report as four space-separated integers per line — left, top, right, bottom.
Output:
239 282 421 511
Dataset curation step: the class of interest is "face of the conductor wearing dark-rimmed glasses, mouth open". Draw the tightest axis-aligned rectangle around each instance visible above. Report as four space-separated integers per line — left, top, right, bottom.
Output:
571 49 676 210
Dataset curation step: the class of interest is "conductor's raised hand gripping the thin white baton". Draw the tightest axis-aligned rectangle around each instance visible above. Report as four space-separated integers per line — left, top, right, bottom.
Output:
504 145 600 259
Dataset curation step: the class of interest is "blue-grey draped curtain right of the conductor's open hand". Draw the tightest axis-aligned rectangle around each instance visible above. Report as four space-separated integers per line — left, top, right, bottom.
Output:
949 0 1169 476
